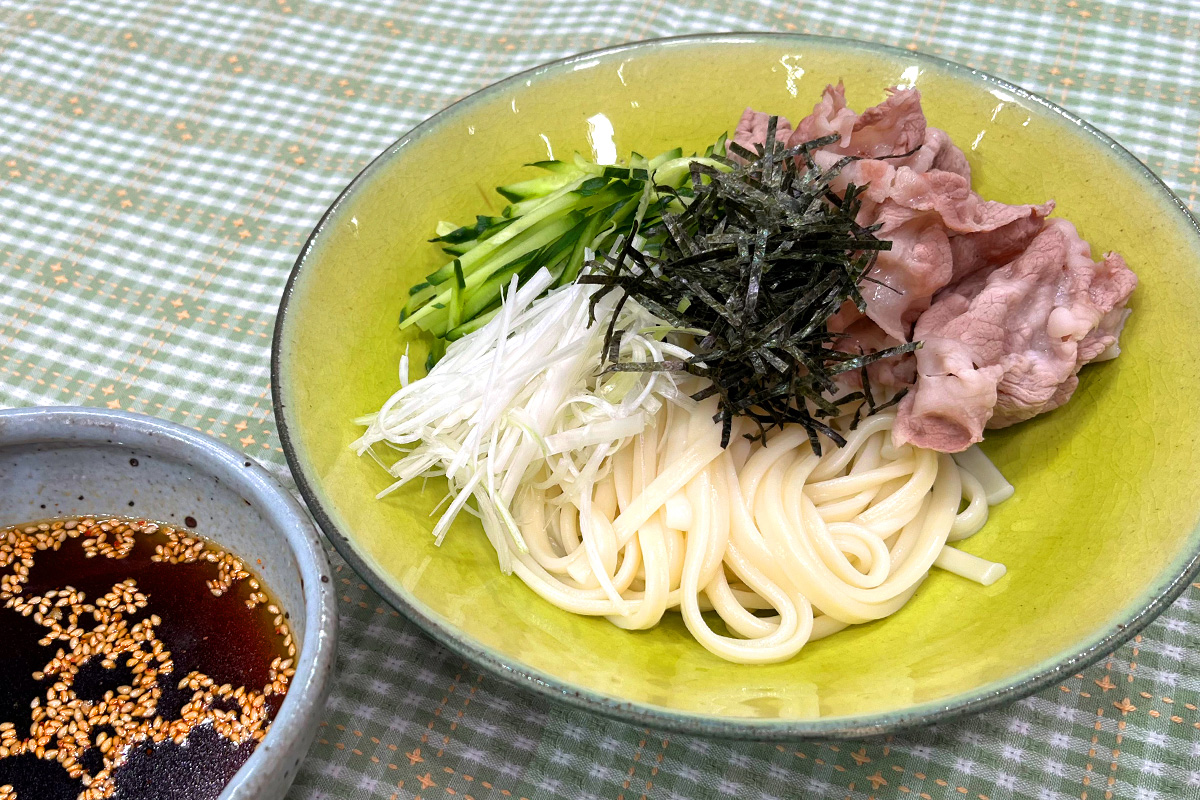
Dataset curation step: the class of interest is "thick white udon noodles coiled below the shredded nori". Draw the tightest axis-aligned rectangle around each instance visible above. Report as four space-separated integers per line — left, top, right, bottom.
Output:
512 401 1012 663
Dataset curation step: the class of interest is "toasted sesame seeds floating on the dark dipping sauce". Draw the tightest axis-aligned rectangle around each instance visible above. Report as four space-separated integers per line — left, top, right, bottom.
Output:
0 517 295 786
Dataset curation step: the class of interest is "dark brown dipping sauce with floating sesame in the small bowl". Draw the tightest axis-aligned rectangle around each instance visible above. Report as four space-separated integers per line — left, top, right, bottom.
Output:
0 518 295 800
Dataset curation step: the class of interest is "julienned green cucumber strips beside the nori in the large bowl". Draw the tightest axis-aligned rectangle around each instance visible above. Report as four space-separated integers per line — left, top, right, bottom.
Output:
400 139 725 353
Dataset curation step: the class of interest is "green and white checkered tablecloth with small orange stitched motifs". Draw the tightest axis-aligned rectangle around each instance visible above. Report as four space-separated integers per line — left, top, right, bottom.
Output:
0 0 1200 800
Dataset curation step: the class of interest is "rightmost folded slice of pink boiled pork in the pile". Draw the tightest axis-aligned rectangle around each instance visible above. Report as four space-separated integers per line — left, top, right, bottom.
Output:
893 219 1138 452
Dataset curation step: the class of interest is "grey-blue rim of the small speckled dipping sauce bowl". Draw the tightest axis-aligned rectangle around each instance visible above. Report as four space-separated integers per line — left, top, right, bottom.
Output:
0 405 338 800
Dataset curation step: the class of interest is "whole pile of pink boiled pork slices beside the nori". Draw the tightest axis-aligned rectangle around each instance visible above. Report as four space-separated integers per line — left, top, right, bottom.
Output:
734 84 1138 452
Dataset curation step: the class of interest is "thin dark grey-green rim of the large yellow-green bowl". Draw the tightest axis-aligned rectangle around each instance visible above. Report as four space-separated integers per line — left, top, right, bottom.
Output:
271 31 1200 741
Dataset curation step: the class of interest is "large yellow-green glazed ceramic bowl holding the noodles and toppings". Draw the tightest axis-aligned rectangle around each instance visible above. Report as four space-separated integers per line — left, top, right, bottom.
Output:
274 34 1200 739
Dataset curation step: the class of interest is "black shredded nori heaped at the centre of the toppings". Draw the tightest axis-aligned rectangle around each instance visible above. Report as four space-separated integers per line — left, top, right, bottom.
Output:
578 118 919 453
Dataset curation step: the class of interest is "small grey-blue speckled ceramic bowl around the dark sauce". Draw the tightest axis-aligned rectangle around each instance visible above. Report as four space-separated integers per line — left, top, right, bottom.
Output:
0 408 337 800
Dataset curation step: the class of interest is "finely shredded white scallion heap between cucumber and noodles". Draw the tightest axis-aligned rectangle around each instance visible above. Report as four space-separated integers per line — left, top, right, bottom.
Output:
353 270 690 572
